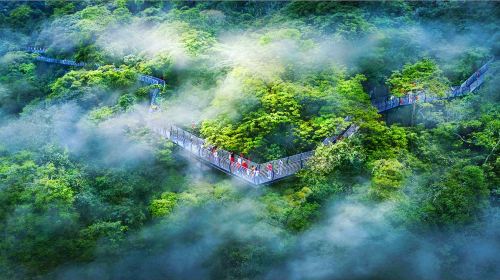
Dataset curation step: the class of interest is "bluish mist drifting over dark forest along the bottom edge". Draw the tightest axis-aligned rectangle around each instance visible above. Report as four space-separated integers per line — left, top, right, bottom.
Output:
51 200 500 279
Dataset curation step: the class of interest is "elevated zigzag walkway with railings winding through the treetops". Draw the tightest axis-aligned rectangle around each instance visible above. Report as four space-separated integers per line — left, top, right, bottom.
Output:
26 47 493 185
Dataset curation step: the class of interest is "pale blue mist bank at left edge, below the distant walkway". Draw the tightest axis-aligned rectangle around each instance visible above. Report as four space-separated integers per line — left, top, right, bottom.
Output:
0 102 153 168
